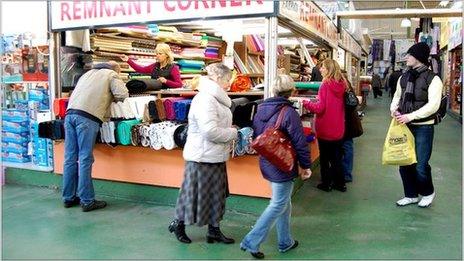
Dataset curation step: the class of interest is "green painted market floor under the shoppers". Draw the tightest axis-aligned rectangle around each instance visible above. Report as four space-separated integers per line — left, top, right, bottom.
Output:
2 97 462 260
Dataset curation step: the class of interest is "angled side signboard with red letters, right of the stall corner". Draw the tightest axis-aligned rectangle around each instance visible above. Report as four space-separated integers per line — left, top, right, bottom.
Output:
279 1 338 48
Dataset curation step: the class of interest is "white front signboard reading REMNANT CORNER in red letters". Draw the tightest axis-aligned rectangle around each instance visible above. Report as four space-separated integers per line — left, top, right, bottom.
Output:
48 0 276 31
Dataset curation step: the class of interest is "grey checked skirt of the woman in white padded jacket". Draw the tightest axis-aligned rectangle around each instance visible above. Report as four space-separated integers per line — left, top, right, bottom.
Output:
176 161 229 226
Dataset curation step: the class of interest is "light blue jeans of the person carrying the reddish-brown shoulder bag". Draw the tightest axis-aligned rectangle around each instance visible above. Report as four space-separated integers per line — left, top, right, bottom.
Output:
240 181 295 253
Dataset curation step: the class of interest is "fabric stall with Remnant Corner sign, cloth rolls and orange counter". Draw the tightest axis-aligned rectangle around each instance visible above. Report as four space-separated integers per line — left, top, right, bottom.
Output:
45 1 366 198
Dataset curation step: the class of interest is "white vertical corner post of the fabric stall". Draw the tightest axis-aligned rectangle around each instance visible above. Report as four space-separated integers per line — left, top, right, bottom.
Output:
264 17 278 99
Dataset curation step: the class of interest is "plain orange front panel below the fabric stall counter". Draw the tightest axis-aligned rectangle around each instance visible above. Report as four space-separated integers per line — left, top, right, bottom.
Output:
54 142 319 198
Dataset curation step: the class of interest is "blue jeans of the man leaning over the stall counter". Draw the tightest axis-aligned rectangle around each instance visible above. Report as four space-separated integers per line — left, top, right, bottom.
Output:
63 114 100 205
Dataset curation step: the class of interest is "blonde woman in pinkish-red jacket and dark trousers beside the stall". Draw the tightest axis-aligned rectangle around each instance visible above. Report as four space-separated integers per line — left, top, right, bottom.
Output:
303 59 346 192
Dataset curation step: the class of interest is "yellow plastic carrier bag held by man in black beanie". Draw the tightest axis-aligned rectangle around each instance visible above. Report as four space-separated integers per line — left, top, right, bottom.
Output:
382 119 417 166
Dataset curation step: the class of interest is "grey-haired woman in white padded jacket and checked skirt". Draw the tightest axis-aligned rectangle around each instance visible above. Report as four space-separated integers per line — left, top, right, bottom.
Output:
169 63 237 244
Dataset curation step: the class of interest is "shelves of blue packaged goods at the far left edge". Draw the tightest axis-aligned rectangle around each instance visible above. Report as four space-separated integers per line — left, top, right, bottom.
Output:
1 34 54 171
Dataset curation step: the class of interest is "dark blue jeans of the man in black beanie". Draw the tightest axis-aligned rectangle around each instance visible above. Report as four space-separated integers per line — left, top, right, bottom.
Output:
400 125 434 198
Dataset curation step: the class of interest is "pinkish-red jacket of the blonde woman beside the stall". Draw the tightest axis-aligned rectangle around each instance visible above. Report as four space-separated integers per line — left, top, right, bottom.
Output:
303 80 345 141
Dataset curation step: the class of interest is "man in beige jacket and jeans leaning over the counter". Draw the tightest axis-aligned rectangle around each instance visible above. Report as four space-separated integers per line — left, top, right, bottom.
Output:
63 61 129 212
